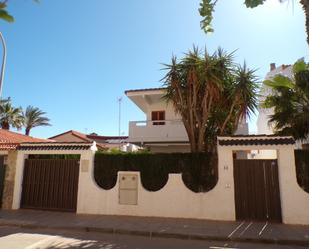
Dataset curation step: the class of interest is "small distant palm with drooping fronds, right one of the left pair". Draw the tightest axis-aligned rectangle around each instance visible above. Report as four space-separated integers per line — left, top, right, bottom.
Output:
23 106 50 136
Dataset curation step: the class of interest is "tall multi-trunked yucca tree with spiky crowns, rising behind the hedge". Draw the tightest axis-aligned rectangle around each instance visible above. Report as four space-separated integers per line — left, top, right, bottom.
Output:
163 47 258 152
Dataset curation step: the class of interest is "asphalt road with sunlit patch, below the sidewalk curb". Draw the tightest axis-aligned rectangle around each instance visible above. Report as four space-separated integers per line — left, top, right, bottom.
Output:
0 227 305 249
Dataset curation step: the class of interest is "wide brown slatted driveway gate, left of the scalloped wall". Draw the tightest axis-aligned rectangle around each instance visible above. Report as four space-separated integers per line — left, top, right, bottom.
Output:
21 159 79 212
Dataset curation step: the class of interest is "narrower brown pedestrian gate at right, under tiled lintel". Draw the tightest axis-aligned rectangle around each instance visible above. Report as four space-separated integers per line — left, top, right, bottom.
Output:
234 159 281 222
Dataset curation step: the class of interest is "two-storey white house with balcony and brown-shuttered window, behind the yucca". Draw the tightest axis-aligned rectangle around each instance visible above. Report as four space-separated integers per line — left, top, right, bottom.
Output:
125 88 248 152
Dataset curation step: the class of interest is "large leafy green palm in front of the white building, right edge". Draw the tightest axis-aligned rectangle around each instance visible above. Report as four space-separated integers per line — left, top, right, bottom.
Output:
263 60 309 140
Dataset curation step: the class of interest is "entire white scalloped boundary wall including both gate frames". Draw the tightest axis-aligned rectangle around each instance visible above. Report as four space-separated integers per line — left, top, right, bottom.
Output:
12 139 309 225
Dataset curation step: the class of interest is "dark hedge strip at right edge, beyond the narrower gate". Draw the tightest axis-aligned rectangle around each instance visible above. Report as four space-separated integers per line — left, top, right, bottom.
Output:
295 150 309 193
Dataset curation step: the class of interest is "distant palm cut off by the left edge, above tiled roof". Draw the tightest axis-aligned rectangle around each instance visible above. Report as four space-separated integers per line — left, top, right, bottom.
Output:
0 99 23 130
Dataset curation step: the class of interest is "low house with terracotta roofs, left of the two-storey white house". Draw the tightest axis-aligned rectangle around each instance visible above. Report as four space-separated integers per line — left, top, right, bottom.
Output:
49 130 135 151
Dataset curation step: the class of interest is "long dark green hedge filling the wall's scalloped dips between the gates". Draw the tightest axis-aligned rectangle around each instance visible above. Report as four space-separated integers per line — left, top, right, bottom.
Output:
94 153 217 192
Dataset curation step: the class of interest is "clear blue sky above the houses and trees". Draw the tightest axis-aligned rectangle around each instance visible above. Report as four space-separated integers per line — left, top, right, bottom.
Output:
0 0 308 137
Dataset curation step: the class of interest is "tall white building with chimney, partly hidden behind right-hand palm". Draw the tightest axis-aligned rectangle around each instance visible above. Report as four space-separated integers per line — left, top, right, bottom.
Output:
257 63 309 157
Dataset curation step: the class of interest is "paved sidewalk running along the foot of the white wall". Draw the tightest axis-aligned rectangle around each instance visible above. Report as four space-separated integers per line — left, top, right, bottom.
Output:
0 210 309 247
